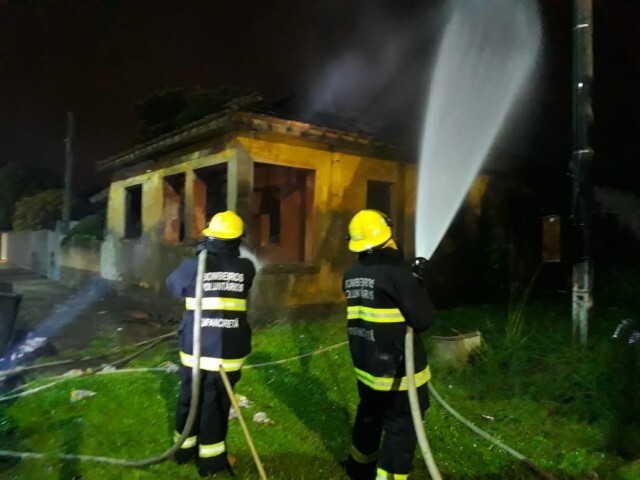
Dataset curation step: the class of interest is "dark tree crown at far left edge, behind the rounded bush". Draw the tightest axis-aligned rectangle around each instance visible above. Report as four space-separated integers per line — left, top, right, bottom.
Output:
0 163 60 230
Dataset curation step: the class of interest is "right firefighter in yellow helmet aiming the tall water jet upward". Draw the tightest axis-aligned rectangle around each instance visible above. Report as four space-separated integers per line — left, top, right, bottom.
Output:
343 210 433 480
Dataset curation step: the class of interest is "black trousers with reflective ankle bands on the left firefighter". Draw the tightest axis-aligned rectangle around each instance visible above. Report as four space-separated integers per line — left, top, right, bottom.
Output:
176 366 240 473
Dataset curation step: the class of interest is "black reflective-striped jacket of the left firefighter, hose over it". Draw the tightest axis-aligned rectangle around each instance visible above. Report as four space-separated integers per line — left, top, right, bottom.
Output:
166 240 256 372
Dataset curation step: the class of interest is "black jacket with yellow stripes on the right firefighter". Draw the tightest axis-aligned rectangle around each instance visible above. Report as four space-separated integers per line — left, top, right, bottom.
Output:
343 248 433 391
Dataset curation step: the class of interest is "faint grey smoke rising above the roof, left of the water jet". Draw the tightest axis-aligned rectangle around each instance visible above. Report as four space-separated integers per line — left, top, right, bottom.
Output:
305 2 438 134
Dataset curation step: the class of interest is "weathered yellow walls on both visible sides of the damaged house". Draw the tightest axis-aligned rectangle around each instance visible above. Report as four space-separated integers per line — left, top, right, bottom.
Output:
107 135 415 307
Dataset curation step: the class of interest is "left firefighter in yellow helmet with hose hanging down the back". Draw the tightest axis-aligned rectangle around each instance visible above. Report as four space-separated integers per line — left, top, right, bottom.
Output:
166 211 256 477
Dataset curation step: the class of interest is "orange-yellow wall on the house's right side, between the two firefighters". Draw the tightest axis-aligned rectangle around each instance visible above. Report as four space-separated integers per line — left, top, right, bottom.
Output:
238 135 398 305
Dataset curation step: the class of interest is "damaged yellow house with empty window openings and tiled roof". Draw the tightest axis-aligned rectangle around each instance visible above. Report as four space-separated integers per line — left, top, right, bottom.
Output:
98 101 416 314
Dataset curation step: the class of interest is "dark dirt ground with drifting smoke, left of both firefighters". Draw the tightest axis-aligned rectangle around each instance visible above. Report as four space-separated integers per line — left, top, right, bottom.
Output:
0 263 181 356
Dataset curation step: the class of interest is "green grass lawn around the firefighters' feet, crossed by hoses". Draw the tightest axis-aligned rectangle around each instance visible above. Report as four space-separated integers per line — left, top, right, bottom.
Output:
0 303 640 480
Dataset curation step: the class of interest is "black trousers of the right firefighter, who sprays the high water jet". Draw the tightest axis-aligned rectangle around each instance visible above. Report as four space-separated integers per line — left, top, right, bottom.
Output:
347 382 429 480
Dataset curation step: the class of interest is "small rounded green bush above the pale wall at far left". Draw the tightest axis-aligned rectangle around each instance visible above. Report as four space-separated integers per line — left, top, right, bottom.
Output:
13 190 64 231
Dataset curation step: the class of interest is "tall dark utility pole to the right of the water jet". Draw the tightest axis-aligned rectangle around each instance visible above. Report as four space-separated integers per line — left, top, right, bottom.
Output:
570 0 594 345
